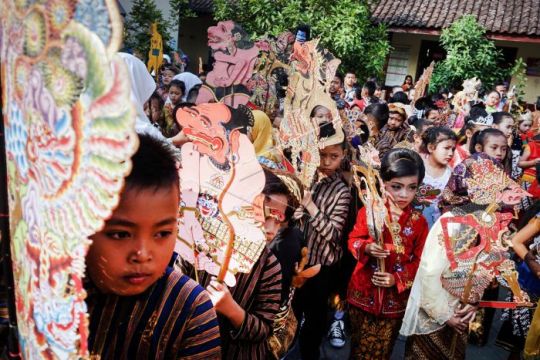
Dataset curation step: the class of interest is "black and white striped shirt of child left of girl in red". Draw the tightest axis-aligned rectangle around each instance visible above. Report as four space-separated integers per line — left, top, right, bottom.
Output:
304 172 351 266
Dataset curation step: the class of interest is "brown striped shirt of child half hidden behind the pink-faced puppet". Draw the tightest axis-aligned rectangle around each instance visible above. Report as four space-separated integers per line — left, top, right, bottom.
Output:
179 247 281 360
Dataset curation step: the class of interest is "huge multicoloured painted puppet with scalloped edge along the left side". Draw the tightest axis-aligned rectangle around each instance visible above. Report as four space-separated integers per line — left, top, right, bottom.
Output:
0 0 137 359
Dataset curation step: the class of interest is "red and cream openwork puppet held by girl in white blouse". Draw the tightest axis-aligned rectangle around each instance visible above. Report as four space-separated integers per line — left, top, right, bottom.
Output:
439 158 527 303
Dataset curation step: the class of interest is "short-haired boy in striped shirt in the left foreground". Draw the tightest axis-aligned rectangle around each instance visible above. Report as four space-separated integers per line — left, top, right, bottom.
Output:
85 135 221 359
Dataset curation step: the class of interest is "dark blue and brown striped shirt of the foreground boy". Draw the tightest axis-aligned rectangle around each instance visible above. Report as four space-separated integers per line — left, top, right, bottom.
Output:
86 267 221 360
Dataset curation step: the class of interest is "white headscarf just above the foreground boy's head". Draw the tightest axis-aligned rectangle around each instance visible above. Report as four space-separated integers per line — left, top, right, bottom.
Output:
118 53 163 138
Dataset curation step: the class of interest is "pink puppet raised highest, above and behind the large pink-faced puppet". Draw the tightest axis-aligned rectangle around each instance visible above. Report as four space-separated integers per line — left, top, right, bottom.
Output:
196 20 259 107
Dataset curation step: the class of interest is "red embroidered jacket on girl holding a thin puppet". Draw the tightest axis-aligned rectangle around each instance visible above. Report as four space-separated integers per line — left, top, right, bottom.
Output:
347 206 429 318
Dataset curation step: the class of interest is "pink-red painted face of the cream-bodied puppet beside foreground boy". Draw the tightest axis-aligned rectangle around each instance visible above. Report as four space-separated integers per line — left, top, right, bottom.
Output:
176 103 231 164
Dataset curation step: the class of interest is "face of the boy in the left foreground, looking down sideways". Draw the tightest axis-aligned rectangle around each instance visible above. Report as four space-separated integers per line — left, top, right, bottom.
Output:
86 186 179 296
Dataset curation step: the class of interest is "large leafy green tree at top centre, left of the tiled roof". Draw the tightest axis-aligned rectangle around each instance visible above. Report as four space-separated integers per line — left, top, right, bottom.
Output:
214 0 390 79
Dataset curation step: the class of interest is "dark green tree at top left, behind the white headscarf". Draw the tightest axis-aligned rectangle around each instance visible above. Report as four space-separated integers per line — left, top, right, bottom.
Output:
124 0 172 59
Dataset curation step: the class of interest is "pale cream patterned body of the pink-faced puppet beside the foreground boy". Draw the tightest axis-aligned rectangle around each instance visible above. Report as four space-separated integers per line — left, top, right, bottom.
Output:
176 135 266 286
